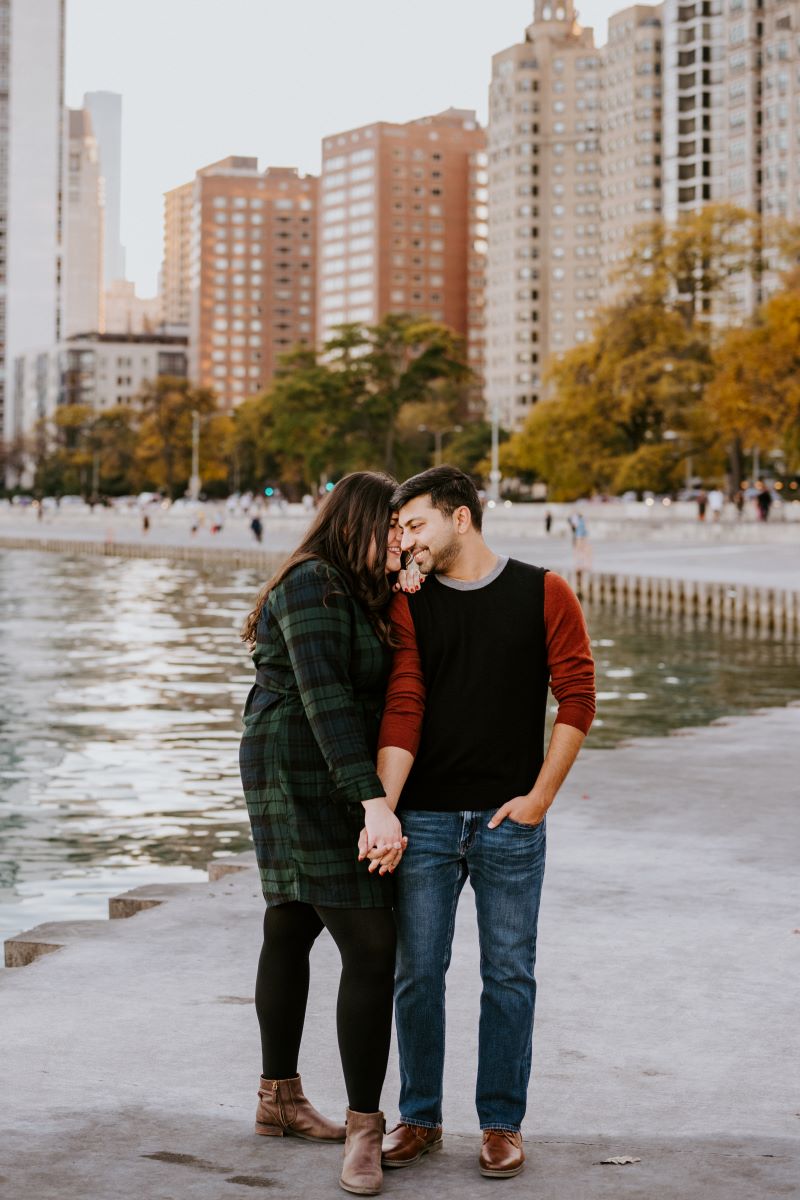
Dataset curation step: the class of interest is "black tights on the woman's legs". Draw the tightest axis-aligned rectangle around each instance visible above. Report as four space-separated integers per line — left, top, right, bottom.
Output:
255 901 396 1112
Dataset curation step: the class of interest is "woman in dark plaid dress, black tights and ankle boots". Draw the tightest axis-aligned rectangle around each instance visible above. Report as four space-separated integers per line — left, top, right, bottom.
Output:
240 472 413 1195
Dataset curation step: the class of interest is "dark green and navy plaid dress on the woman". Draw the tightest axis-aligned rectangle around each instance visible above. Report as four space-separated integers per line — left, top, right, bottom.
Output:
239 560 392 908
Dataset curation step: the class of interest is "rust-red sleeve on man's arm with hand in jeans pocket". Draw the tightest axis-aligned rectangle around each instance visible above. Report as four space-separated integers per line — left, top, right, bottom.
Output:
545 571 595 733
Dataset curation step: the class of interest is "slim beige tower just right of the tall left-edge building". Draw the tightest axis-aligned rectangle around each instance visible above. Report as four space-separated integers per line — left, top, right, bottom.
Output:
64 108 103 337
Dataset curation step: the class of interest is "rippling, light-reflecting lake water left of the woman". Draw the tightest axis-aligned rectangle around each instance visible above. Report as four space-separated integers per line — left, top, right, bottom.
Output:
0 552 255 934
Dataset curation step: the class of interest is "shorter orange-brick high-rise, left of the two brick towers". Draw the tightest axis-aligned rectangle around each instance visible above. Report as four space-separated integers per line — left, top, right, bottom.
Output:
190 156 319 408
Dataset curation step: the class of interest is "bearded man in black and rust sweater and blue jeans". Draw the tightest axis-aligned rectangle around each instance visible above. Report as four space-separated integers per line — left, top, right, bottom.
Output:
371 467 595 1178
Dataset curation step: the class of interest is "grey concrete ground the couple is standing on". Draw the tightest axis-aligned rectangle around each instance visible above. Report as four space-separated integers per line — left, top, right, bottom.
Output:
0 707 800 1200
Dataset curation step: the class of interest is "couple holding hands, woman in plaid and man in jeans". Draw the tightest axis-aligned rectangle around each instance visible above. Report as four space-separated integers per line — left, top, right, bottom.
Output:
240 467 594 1195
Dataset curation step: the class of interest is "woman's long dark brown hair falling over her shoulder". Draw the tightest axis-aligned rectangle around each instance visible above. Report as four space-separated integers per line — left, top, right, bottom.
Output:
241 470 397 647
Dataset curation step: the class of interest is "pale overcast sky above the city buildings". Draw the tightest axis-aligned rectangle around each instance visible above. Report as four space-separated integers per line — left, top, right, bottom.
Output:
66 0 627 295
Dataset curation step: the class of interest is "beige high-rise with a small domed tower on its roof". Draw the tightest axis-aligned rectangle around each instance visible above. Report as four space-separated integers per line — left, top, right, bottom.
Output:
486 0 602 428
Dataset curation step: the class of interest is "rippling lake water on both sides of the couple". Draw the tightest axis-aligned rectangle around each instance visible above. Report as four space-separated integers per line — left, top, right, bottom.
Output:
0 551 800 940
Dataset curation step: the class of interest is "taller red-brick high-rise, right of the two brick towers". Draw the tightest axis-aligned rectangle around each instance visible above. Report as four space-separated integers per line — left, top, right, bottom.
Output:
318 109 487 355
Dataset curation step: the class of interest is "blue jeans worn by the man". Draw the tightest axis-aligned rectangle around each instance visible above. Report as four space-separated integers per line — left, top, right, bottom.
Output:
395 810 546 1129
